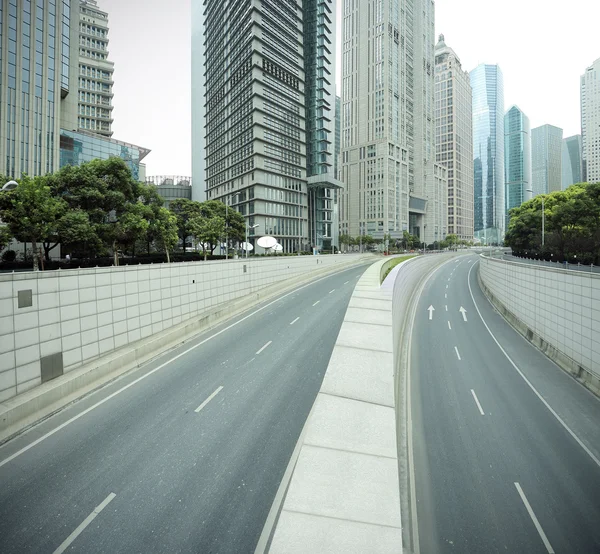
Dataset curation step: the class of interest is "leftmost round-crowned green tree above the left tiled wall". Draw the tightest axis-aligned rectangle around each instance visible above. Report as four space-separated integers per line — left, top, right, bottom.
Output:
0 175 65 271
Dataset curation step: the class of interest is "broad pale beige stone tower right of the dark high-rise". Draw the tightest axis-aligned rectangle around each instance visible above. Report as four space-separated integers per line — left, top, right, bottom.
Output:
340 0 446 243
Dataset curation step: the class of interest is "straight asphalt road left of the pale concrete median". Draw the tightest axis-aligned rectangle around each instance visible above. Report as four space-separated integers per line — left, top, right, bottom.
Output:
0 260 366 554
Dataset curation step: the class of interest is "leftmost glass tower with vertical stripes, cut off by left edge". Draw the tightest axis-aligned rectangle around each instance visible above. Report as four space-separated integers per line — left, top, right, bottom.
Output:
0 0 78 178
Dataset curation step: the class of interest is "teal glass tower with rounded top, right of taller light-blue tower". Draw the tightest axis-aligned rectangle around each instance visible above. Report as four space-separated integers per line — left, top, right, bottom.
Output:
504 106 532 229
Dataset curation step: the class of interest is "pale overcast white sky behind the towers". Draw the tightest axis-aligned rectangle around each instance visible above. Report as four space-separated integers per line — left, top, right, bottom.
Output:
98 0 600 175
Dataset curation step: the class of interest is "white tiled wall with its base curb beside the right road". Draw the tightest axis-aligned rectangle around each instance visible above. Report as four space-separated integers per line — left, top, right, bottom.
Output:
479 256 600 394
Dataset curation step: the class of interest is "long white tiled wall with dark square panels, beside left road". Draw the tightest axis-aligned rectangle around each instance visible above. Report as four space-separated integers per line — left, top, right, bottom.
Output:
0 254 365 402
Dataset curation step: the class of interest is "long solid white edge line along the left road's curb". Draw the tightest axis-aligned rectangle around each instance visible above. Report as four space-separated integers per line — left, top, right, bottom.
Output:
0 267 361 467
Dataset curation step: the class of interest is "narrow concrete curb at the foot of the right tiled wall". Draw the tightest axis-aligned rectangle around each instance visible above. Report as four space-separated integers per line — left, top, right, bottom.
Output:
477 260 600 396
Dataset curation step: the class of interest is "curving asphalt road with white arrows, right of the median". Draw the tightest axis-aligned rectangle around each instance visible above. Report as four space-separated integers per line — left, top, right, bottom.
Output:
410 256 600 554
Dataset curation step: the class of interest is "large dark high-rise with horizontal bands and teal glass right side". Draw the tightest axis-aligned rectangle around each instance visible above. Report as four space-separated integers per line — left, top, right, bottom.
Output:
192 0 338 252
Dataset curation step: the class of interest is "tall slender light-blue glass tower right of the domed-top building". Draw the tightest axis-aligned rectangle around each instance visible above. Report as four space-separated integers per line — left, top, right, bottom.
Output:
470 64 505 244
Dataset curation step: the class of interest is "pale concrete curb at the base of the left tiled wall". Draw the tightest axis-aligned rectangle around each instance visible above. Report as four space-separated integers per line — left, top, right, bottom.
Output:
0 255 373 443
